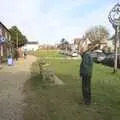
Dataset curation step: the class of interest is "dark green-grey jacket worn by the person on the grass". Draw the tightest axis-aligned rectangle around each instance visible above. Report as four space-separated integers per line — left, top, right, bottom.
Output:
80 52 93 76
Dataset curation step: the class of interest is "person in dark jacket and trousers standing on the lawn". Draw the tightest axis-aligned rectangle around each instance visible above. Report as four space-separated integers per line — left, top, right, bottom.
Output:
80 46 93 105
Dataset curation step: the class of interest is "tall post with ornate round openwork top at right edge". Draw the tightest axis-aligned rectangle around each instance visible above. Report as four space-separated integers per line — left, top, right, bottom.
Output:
108 3 120 73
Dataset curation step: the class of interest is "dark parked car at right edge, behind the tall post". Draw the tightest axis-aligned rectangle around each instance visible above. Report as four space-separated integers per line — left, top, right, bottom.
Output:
102 54 120 68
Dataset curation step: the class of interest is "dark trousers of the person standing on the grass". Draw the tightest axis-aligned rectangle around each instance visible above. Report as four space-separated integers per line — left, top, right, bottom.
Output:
82 75 91 104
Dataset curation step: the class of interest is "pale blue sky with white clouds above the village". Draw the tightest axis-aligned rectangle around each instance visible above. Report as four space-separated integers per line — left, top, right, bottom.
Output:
0 0 119 44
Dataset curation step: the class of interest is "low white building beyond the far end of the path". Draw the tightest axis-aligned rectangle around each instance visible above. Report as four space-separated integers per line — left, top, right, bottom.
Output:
23 41 39 51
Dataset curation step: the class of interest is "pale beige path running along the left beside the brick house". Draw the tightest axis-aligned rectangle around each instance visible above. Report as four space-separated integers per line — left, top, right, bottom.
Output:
0 56 36 120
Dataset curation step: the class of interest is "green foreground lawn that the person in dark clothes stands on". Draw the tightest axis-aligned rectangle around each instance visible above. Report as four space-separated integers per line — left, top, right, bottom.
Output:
24 51 120 120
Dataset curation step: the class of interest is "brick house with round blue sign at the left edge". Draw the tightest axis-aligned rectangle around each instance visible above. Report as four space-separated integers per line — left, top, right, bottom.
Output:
0 22 11 63
